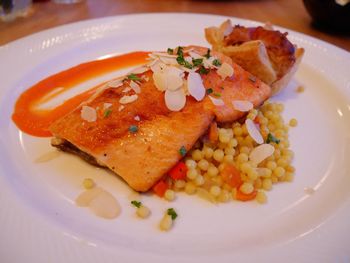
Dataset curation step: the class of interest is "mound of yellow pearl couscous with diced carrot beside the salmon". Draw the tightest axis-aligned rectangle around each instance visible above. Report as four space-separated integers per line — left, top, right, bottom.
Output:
164 101 297 204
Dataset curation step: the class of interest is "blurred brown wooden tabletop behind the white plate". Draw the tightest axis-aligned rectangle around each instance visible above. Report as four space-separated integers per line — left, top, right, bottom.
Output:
0 0 350 51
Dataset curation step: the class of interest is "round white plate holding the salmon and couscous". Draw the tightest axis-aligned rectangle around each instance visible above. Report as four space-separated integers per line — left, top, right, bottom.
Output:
0 14 350 263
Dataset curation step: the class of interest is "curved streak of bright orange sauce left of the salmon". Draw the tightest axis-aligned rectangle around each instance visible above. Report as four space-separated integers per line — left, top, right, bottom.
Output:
12 52 148 137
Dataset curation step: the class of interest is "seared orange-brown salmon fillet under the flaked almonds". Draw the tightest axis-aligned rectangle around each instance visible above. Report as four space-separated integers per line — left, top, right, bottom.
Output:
50 46 271 191
